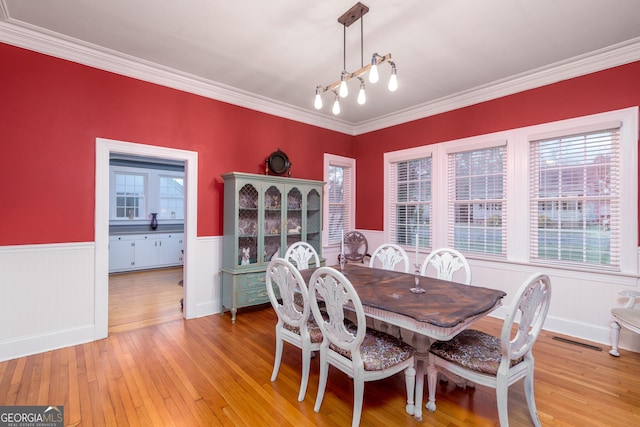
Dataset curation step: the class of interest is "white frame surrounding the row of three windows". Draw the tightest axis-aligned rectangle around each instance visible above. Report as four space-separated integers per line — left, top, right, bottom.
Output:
383 107 639 276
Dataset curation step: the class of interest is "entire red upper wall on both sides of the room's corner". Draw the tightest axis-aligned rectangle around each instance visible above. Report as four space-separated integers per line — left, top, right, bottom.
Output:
0 43 640 246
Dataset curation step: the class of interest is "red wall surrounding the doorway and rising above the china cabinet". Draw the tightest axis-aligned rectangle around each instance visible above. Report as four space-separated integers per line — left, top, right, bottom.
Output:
0 43 353 246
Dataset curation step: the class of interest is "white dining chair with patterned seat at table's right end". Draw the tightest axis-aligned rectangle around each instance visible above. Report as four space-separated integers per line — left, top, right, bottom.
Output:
427 274 551 427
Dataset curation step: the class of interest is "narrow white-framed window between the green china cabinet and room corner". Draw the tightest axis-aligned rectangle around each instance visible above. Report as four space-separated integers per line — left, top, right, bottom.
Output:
324 154 355 245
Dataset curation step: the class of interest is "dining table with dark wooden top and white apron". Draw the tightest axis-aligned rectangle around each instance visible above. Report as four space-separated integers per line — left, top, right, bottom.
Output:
300 264 506 420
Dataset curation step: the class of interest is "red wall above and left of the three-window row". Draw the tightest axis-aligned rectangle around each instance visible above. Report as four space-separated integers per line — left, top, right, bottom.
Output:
355 62 640 230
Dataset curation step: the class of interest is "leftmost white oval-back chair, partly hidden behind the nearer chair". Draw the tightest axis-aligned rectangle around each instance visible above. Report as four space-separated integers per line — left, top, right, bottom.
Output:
266 258 322 402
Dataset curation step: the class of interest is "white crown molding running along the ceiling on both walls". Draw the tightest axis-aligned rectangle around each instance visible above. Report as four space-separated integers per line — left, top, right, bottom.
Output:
0 6 640 135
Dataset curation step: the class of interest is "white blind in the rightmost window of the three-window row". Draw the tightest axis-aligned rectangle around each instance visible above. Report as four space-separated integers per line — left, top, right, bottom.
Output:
530 127 621 268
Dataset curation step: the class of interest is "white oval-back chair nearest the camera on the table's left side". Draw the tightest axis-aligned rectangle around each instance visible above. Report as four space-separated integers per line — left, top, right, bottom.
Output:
309 267 416 426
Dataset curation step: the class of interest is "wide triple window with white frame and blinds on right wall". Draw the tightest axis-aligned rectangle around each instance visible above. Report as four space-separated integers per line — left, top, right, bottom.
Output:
384 107 639 277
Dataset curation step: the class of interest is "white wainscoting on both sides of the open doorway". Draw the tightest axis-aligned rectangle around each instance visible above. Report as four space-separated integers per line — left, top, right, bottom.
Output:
0 237 222 361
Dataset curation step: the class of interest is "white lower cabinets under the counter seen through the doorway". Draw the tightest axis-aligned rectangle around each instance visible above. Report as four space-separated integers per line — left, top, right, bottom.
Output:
109 233 184 273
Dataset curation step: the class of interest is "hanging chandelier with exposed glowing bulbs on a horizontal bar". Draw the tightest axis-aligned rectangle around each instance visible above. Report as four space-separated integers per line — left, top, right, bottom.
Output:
313 2 398 115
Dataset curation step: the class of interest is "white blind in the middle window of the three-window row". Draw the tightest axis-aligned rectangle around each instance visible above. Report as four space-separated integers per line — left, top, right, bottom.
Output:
447 146 507 256
